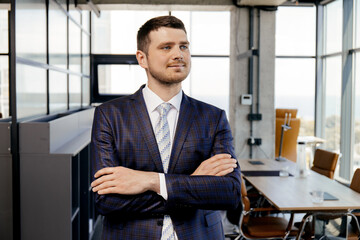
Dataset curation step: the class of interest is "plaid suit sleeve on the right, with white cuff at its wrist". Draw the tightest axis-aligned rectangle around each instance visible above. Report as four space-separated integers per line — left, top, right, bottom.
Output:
165 111 241 210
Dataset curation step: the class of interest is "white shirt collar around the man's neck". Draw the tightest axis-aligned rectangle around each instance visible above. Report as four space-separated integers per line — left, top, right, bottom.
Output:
143 85 183 113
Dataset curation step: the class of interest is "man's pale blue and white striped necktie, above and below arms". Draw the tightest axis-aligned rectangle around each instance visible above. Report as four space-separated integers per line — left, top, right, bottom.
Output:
155 103 177 240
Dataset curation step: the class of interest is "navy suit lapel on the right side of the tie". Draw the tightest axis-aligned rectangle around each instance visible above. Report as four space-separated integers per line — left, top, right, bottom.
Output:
168 93 195 173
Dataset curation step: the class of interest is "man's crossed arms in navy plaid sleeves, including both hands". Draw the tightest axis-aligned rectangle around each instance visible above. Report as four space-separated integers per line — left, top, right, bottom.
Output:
91 106 241 215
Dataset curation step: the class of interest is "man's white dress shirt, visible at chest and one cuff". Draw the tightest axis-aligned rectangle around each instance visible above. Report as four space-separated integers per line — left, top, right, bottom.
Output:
143 85 182 200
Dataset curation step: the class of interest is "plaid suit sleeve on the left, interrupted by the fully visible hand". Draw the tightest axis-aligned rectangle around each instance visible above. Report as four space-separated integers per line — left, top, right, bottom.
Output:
91 108 164 215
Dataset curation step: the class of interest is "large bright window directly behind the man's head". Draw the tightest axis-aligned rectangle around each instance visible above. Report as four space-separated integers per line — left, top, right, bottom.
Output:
92 10 230 115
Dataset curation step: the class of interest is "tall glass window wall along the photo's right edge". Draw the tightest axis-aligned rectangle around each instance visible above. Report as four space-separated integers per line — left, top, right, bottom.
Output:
316 0 360 180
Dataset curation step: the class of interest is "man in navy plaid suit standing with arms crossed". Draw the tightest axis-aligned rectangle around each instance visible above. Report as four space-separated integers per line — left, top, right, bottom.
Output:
91 16 241 240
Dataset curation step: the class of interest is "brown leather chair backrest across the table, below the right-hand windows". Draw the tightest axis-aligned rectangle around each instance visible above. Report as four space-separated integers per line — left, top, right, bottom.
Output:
311 149 339 179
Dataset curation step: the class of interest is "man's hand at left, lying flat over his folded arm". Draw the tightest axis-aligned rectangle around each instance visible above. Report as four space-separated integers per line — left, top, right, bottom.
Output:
91 167 160 195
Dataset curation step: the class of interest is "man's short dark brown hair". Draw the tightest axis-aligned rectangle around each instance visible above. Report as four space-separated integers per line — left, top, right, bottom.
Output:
137 16 186 54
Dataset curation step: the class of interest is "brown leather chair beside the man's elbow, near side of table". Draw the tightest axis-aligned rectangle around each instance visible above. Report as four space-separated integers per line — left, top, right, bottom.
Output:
225 174 297 240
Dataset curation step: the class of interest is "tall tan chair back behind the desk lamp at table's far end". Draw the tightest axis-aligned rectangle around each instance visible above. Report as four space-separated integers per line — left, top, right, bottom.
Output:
275 108 300 162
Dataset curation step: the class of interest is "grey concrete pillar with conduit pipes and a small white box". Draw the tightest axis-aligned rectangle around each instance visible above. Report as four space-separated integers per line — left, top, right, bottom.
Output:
229 8 276 159
